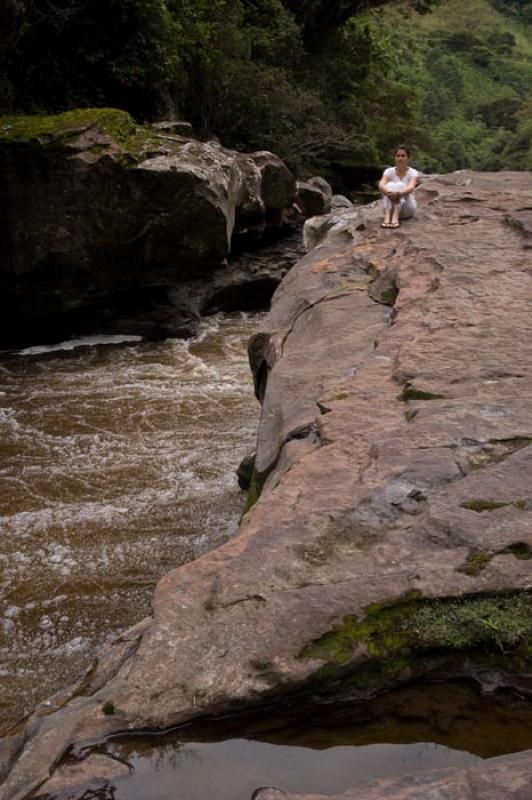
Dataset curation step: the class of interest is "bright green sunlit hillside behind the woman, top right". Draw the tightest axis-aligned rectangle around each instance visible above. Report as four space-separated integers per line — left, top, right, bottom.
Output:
385 0 532 171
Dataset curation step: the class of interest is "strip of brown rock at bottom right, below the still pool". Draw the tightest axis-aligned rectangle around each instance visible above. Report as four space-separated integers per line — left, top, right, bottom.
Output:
252 751 532 800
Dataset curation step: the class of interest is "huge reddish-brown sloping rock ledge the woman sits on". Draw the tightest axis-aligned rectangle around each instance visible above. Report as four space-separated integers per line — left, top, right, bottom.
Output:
0 172 532 800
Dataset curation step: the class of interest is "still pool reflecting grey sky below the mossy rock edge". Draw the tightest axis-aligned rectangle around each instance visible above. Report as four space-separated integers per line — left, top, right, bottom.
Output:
63 682 532 800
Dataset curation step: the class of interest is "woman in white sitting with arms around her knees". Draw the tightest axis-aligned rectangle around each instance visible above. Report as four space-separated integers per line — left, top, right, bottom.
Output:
379 144 419 228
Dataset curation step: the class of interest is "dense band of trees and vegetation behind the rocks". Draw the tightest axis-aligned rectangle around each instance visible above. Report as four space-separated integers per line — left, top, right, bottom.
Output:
0 0 532 172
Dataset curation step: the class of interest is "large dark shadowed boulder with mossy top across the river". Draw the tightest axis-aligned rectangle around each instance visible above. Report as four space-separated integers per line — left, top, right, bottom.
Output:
0 109 295 345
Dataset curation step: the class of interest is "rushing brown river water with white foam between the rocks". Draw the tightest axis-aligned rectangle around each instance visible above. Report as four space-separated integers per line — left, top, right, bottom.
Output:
0 313 259 732
